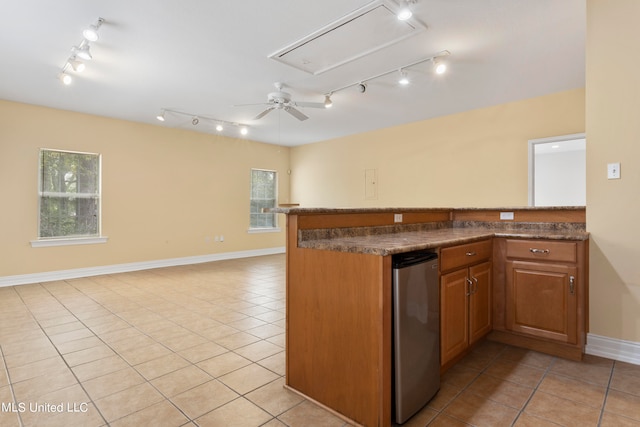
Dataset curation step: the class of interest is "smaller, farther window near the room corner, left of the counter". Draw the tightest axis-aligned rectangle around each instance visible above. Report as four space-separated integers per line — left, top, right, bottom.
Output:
249 169 278 230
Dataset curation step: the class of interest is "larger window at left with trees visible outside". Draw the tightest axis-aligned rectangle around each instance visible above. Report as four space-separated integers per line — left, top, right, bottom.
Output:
38 149 100 238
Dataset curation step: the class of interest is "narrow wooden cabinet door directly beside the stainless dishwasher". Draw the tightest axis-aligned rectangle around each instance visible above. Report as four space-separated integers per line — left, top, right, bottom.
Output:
440 268 469 365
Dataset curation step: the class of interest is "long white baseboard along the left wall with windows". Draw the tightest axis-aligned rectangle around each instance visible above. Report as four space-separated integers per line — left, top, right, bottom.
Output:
0 247 285 287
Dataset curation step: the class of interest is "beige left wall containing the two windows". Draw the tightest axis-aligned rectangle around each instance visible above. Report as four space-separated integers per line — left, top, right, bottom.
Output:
0 101 290 276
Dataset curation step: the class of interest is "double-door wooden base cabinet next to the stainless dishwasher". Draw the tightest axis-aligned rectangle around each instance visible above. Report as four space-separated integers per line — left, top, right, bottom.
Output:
440 240 492 366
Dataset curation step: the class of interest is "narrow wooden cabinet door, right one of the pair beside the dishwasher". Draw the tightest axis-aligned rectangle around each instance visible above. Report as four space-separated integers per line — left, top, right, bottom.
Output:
469 262 491 344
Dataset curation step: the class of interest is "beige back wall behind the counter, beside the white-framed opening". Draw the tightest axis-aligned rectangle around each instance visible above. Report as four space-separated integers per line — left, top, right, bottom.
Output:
291 89 585 207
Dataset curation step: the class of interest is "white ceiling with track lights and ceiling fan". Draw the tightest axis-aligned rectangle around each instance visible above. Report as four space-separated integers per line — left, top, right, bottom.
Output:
0 0 586 146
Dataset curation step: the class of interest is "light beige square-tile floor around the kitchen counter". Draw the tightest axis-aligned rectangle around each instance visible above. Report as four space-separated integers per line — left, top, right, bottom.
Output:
0 255 640 427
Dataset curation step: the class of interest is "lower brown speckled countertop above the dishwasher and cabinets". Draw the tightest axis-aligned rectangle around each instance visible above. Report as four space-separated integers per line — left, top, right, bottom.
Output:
298 227 589 256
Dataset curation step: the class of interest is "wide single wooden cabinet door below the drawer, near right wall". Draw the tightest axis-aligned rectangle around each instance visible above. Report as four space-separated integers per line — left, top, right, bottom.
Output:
506 261 578 344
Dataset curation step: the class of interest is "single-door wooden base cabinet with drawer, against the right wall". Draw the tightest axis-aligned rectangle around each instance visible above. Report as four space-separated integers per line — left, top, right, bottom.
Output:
492 239 588 359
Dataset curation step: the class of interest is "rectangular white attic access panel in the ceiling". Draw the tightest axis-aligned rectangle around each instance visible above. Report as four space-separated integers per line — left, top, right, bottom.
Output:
269 0 427 75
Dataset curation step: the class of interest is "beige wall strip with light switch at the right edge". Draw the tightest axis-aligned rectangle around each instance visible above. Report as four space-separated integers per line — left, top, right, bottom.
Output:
586 0 640 342
